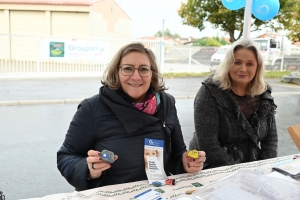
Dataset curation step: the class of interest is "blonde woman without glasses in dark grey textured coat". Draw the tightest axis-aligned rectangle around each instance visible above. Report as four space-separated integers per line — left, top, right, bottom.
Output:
190 39 278 169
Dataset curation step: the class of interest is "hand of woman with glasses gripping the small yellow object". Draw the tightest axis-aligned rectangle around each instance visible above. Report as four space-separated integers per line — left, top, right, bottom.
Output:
182 151 206 173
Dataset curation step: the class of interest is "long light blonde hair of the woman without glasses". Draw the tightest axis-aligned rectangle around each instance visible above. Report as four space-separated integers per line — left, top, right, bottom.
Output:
213 38 267 97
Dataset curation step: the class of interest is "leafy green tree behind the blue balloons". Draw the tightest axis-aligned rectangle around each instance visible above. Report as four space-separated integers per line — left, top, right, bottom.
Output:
178 0 300 42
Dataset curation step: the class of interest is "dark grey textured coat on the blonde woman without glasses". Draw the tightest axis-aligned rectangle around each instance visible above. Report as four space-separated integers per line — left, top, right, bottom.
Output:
189 78 278 168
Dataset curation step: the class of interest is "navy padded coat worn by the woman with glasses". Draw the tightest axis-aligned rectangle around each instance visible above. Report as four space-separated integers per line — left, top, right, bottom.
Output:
57 87 186 190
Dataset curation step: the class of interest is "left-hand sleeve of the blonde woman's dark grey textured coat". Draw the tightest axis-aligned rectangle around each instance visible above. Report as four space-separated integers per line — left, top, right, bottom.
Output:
189 85 235 167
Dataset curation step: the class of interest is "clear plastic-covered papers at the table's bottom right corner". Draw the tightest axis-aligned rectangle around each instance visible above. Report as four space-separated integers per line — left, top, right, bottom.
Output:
191 169 300 200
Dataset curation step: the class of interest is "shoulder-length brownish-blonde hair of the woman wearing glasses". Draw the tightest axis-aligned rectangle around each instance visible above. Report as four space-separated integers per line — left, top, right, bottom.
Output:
101 43 166 92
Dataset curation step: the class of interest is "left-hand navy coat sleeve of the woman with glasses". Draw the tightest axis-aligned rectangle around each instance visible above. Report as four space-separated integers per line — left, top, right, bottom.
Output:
57 100 104 190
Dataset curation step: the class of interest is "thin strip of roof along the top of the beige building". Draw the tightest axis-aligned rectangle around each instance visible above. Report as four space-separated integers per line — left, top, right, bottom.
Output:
0 0 105 6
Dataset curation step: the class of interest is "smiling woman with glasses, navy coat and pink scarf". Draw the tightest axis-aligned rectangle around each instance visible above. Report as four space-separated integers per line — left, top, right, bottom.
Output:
57 43 205 190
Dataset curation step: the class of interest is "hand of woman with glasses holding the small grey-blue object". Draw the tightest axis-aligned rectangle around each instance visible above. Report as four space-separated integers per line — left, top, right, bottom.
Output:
86 150 118 179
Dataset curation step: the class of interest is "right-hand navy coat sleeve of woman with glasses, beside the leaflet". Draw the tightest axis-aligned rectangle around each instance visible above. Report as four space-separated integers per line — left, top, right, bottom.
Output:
165 95 186 175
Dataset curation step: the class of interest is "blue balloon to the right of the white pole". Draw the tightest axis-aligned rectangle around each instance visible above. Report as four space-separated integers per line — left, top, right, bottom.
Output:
252 0 280 20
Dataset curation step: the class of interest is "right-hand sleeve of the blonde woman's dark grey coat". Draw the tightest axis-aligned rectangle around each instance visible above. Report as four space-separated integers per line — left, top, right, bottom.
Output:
259 103 278 160
